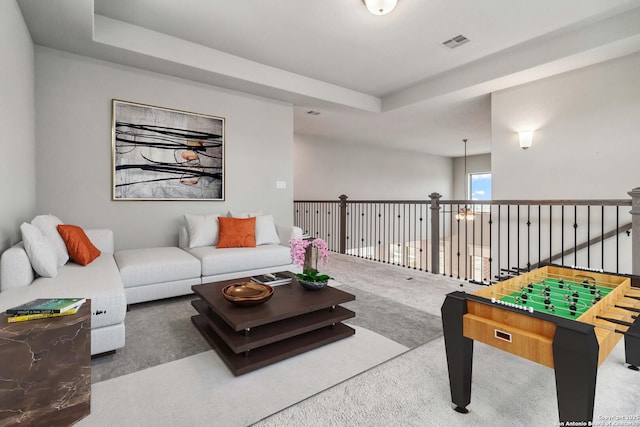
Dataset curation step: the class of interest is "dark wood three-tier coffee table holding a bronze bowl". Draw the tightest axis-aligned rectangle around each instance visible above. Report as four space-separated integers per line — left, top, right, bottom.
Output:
191 278 355 376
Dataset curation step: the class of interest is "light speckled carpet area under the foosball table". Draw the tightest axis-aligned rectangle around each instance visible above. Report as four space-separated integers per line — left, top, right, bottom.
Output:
254 328 640 427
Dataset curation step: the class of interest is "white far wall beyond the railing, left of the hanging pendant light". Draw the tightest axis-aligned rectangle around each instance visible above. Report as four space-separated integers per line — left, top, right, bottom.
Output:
294 134 452 200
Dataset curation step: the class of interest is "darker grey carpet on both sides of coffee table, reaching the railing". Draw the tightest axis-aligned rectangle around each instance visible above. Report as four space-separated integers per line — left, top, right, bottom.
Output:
91 254 460 384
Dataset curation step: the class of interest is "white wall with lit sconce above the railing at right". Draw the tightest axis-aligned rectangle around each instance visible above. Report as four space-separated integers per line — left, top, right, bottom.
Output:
491 54 640 199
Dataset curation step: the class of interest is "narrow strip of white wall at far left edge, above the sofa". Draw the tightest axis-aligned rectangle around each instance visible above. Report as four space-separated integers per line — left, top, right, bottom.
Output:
0 0 36 252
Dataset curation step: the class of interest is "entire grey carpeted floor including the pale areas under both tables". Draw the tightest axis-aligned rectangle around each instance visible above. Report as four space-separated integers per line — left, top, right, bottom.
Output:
89 254 640 427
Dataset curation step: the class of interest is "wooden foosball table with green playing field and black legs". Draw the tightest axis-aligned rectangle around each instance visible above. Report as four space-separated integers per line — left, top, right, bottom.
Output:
441 265 640 425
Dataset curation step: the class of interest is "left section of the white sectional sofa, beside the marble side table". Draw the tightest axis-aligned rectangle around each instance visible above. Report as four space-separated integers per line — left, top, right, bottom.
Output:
0 229 127 355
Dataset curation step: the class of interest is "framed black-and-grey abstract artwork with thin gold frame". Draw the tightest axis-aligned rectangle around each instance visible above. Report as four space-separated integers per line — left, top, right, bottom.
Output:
111 99 225 200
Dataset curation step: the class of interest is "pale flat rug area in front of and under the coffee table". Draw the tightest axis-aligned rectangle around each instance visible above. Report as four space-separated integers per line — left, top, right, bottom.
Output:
76 326 407 427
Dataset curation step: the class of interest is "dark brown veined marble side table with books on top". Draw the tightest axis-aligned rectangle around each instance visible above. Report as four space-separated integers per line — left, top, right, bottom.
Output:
0 300 91 426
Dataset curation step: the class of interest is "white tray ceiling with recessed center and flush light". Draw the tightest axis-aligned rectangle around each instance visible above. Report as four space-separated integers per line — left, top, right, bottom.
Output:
18 0 640 156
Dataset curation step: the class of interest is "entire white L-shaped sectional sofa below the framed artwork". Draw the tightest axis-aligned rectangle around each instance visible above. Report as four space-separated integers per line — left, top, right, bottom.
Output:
0 214 302 355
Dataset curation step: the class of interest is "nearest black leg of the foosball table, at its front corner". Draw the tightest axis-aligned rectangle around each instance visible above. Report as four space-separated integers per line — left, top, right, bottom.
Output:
553 322 600 425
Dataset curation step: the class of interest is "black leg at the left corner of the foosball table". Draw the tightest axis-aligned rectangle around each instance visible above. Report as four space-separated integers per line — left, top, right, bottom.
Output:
441 292 473 414
